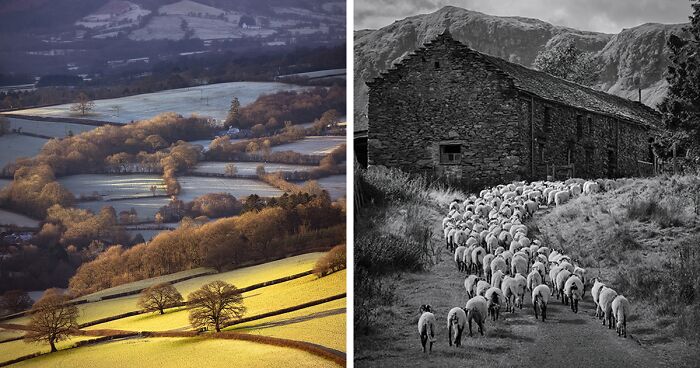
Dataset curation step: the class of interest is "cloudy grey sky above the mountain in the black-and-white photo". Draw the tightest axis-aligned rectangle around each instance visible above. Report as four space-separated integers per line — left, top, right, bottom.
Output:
355 0 691 33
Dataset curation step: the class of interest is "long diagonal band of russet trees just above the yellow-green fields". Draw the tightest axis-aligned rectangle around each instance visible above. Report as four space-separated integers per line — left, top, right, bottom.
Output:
69 195 345 295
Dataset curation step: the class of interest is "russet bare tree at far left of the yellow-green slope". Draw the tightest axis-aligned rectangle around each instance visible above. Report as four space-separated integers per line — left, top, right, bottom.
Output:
24 289 78 352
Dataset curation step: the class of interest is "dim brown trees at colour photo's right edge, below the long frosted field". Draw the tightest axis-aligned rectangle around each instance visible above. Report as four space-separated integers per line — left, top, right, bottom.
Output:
230 86 346 133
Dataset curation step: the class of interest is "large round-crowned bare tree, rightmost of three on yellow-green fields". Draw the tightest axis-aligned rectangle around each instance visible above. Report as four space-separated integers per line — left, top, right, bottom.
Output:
187 280 246 332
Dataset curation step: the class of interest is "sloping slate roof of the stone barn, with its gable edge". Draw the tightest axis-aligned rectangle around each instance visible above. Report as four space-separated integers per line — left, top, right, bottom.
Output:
368 31 661 128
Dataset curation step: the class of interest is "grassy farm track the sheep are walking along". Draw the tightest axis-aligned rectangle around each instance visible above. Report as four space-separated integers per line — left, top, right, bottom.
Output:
355 206 677 368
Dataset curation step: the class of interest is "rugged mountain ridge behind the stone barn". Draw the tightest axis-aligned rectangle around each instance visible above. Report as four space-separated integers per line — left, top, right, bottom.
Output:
354 6 683 130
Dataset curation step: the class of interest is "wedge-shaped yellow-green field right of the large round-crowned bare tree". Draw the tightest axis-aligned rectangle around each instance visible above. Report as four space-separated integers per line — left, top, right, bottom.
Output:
226 298 347 351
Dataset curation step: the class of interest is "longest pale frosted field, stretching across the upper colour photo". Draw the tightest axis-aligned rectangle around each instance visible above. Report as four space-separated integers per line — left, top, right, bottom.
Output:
13 82 308 123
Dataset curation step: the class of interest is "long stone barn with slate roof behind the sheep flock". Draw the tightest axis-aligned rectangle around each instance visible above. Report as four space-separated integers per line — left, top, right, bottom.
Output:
356 31 661 185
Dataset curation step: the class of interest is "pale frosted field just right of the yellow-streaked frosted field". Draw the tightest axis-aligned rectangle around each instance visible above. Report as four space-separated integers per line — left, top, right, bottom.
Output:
177 176 283 202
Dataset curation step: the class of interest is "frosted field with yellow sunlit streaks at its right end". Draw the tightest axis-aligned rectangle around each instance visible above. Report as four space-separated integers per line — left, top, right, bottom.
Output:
58 174 165 200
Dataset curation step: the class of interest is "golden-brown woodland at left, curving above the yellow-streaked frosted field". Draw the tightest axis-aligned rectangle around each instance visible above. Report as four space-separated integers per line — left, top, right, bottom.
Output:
0 113 213 218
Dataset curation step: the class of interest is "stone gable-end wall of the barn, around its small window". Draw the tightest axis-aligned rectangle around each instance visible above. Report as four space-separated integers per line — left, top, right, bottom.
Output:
367 39 528 187
